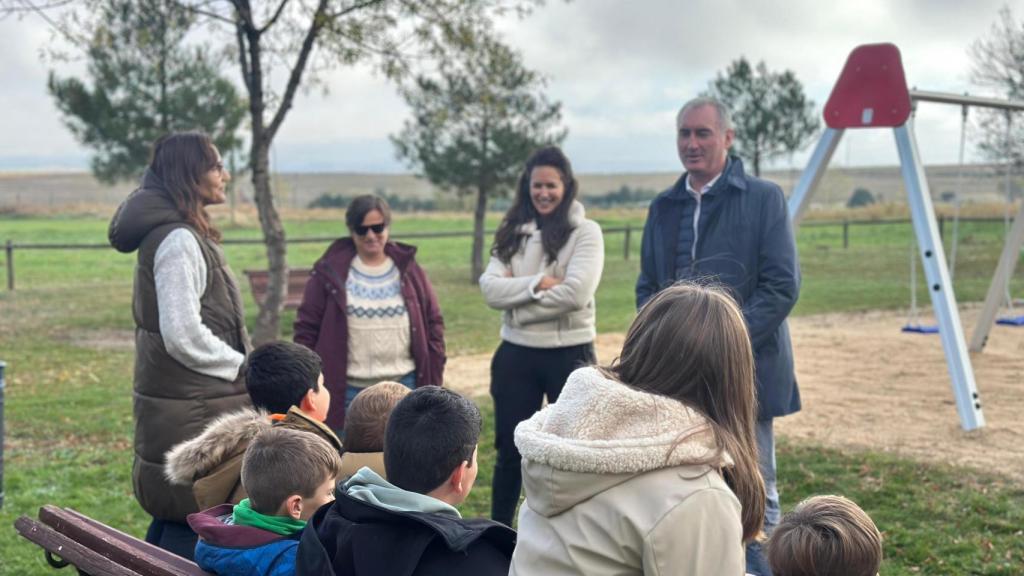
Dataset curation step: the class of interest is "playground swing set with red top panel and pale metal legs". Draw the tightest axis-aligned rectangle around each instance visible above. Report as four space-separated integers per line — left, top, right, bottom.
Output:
788 44 1024 430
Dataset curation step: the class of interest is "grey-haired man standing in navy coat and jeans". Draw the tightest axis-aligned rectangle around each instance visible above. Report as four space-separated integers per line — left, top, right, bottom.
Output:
636 97 800 575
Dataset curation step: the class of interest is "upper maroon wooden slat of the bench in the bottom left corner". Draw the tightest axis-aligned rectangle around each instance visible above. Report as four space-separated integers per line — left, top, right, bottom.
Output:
39 505 207 576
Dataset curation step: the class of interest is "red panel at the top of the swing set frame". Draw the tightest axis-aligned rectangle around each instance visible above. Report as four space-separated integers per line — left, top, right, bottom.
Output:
824 44 911 129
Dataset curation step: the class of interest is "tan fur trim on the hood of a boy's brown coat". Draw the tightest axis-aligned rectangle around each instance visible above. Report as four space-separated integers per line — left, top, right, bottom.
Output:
164 408 271 484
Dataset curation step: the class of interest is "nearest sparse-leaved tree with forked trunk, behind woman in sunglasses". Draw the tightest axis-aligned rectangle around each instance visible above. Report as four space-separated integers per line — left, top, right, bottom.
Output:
8 0 543 343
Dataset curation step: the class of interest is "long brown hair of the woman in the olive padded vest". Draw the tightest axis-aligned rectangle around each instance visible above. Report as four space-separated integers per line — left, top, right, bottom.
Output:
150 132 220 242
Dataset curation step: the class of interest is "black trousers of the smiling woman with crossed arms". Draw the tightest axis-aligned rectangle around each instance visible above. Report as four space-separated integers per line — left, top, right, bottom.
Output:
490 341 597 526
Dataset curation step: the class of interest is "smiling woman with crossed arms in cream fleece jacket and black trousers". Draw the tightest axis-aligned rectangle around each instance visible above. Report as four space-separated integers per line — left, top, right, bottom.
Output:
480 147 604 526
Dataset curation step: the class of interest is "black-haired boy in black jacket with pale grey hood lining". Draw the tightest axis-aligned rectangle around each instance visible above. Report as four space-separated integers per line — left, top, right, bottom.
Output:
296 386 515 576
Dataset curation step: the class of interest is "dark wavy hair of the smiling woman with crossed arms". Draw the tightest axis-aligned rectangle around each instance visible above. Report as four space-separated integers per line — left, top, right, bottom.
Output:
490 146 579 263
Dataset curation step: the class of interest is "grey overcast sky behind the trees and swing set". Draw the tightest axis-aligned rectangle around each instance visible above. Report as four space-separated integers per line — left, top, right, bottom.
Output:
0 0 1022 172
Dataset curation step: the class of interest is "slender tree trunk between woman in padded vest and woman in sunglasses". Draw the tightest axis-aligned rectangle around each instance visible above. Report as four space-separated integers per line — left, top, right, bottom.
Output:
251 137 288 345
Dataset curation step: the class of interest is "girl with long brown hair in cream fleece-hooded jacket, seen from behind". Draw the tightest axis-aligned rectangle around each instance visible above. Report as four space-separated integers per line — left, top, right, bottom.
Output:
510 285 765 576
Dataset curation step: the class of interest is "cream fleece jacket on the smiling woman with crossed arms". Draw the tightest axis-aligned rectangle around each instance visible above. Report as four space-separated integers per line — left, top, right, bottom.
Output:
480 201 604 348
